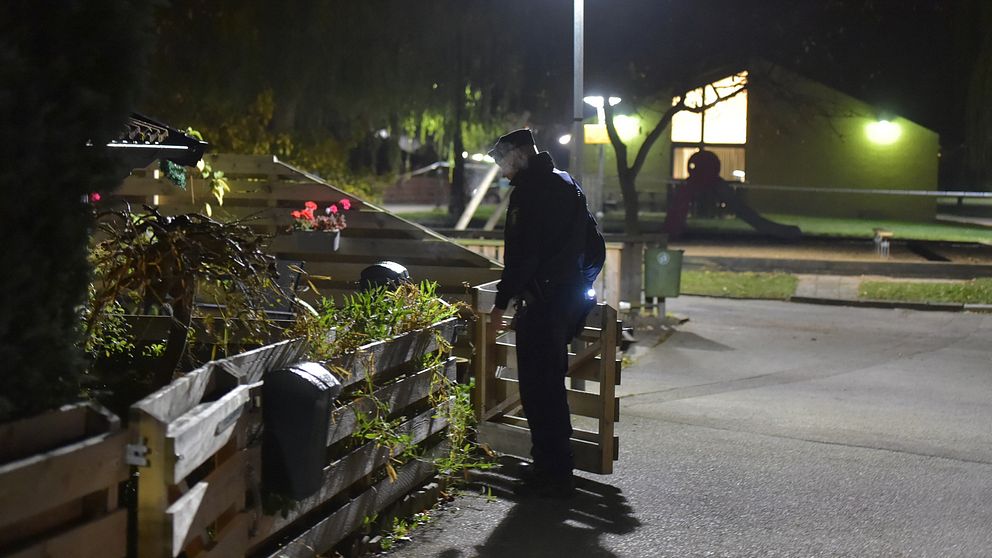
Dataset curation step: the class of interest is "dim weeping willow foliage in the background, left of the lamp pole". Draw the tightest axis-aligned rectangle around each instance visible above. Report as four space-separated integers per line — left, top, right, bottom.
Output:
146 0 571 211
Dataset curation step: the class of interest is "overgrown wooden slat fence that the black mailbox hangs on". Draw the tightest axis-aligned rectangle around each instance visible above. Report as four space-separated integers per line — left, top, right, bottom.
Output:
132 319 456 557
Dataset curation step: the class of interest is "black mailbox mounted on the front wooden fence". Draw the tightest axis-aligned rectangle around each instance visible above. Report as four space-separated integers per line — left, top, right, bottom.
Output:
262 362 341 500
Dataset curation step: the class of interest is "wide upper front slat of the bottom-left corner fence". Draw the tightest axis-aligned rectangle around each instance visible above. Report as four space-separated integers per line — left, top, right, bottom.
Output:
0 432 128 525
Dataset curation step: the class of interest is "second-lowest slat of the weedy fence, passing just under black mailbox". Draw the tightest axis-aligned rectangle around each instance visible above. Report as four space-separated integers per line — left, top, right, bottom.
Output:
252 409 448 546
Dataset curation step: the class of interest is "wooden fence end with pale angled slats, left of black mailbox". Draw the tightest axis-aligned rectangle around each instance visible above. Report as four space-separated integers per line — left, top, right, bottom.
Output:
130 340 303 557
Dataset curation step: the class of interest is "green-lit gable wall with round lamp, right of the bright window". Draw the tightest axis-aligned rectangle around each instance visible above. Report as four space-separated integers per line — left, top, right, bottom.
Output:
747 68 939 220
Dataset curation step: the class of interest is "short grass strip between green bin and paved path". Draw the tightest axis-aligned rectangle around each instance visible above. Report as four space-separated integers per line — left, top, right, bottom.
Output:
682 271 799 300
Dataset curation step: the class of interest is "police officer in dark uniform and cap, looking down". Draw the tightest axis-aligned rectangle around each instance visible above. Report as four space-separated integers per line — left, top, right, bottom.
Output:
489 129 602 497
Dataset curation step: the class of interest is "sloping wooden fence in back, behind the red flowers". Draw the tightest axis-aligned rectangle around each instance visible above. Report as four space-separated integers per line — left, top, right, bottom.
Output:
111 154 500 300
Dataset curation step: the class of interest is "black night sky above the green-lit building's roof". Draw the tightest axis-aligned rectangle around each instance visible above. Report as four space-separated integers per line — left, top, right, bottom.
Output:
532 0 981 144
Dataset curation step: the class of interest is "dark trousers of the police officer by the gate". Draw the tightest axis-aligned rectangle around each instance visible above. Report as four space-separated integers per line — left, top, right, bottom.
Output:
516 288 582 475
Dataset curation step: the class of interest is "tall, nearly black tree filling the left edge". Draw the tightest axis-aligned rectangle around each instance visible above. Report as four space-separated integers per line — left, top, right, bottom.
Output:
0 0 150 421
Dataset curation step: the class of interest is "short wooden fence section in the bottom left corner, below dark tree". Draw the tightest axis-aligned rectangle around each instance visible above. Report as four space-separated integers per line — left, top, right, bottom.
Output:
0 404 128 558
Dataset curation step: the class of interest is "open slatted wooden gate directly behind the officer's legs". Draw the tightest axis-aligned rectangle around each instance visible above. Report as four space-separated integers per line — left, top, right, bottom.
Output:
472 281 621 475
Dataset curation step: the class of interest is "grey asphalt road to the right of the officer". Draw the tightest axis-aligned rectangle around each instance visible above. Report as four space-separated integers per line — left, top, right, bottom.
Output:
390 297 992 558
